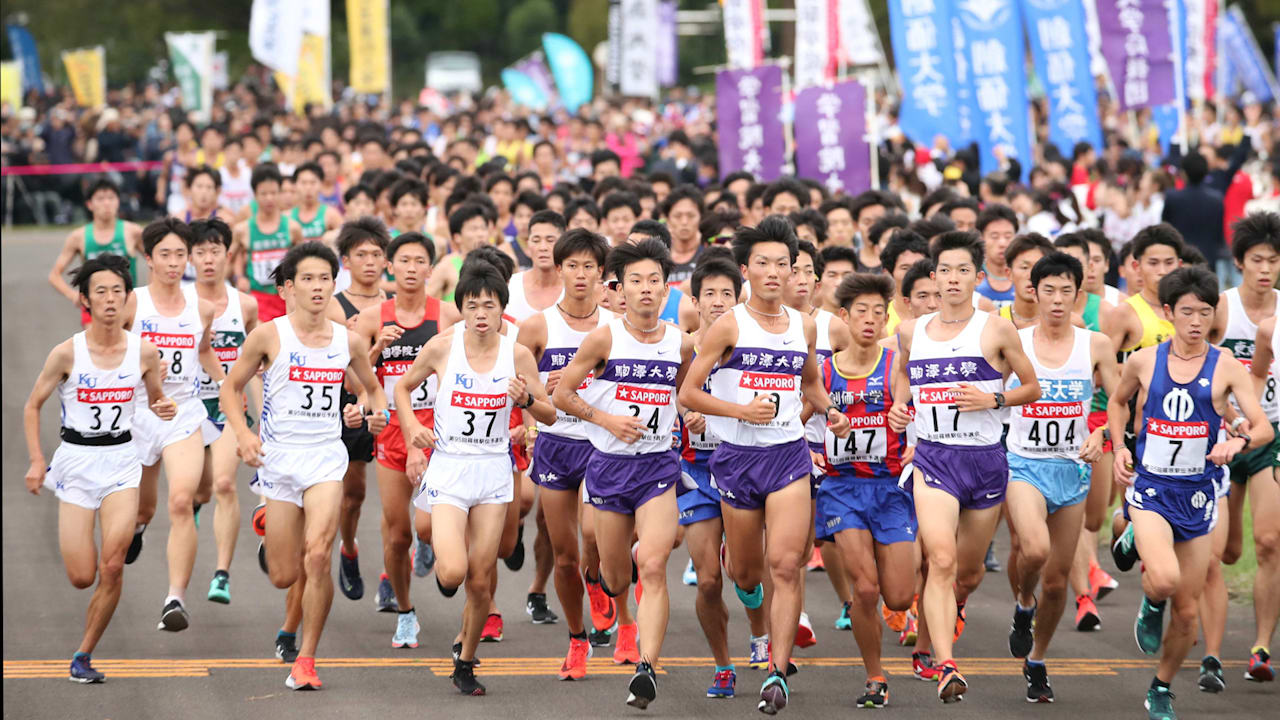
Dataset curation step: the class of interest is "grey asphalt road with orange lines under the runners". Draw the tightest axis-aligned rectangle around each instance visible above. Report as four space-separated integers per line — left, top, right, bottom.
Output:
0 231 1277 720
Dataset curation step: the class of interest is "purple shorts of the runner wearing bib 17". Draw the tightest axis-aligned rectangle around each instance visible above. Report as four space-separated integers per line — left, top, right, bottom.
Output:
913 439 1009 510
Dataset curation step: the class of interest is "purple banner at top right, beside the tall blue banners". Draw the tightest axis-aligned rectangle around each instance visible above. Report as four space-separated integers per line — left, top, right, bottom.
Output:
1097 0 1178 110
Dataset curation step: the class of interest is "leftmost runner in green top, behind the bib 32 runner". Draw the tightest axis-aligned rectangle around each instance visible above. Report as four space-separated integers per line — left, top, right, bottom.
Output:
49 178 142 327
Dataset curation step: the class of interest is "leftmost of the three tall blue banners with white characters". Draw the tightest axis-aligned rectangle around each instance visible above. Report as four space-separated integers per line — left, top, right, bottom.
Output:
888 0 960 146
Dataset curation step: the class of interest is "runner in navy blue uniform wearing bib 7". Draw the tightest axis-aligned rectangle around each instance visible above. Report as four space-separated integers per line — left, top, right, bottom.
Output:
1107 266 1274 720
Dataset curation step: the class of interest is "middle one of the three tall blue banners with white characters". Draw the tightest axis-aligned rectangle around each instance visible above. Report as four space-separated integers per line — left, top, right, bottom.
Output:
956 0 1033 179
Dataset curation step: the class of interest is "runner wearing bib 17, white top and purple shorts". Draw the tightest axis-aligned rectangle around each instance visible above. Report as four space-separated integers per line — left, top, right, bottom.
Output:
890 230 1039 702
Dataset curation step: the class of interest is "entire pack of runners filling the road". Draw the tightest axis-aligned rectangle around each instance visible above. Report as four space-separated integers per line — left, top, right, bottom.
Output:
24 158 1280 719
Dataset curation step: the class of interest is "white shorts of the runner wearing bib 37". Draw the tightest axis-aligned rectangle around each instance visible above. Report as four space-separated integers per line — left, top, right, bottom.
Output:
413 450 515 512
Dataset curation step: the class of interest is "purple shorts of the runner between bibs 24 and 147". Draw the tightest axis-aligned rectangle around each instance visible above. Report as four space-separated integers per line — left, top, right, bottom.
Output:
709 438 813 510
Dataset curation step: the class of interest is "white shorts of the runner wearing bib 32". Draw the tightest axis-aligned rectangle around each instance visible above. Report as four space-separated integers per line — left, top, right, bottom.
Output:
45 442 142 510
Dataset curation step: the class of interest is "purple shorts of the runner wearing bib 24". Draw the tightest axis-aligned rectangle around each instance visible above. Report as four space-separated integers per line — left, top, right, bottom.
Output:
585 450 681 515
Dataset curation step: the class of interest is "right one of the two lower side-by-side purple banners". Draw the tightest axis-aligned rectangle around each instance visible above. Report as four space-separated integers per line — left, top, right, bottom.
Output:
795 81 872 195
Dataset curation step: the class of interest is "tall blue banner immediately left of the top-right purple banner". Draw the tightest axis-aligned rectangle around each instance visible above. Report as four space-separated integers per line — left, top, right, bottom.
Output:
1021 0 1102 158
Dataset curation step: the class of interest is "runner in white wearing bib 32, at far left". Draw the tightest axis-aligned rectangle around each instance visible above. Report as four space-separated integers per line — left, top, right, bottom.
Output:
23 254 178 683
